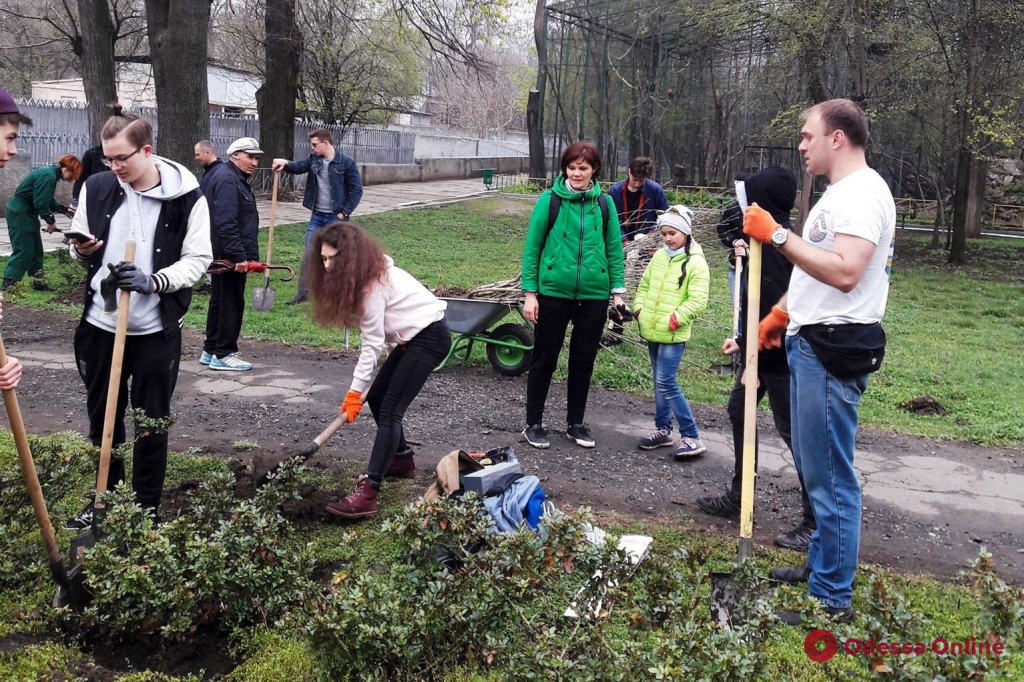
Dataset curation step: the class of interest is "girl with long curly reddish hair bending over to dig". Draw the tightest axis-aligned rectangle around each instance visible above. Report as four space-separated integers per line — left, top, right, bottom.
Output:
303 222 452 518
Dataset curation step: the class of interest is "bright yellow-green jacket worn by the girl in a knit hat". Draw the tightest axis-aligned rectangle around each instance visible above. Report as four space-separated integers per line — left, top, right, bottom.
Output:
633 242 711 343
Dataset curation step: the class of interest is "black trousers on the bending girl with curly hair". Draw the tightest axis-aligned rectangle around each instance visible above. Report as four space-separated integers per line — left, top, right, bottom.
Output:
367 319 452 484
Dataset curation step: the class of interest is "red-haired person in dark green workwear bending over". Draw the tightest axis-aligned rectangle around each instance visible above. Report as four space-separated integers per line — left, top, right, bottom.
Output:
2 154 82 289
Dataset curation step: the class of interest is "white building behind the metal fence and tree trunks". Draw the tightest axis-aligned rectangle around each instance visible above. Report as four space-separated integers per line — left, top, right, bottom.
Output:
32 63 262 114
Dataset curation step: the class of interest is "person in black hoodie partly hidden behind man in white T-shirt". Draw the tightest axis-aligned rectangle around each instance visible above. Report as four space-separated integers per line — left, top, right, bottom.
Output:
697 167 815 550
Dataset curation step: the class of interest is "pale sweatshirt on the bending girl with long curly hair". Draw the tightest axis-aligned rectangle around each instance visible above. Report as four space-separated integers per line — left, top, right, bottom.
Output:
352 256 447 393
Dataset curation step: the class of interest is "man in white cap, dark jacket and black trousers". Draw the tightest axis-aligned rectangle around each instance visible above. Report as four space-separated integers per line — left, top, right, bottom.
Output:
199 137 263 372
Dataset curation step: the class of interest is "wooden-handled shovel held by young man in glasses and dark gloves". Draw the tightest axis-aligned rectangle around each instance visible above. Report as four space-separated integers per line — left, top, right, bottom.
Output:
69 242 135 584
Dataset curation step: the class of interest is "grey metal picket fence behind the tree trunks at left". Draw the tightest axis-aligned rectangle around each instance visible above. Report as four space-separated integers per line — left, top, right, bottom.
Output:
18 100 416 168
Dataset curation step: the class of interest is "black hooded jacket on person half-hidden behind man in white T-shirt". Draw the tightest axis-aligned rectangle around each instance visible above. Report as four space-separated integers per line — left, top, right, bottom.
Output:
737 167 797 374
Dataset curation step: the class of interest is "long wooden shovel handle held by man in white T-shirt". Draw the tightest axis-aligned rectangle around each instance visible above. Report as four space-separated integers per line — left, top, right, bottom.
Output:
737 240 761 561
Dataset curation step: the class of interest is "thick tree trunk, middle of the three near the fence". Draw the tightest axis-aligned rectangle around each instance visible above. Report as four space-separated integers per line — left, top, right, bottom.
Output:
145 0 210 171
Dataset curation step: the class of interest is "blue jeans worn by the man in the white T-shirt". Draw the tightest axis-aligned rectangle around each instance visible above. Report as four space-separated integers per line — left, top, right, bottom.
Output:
785 336 867 608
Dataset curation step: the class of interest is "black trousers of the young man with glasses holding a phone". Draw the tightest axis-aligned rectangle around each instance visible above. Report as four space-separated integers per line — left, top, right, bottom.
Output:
75 321 181 512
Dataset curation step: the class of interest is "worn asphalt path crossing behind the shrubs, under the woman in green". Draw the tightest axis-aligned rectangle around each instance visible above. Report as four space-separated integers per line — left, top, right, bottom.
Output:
0 306 1024 582
